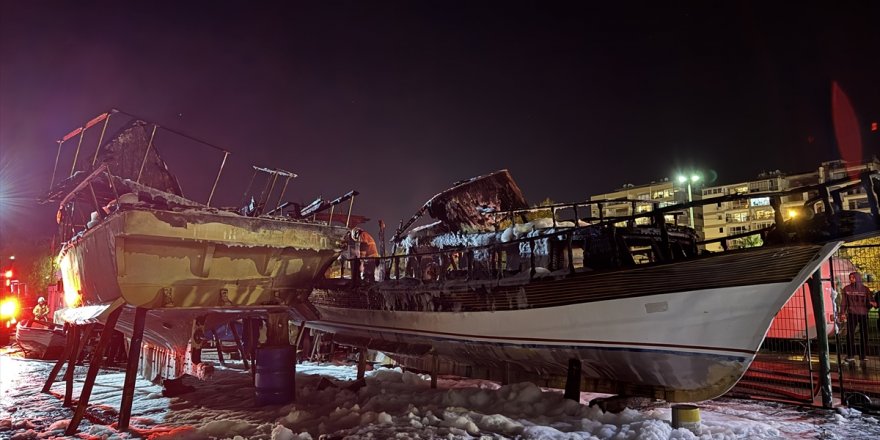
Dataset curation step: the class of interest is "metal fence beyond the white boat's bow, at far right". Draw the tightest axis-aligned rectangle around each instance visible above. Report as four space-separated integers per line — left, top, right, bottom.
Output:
731 240 880 408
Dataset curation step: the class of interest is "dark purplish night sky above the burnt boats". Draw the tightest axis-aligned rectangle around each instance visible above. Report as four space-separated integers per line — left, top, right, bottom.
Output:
0 1 880 248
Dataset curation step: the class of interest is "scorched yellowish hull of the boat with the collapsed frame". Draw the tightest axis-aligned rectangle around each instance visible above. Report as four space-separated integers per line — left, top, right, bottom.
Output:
60 209 347 353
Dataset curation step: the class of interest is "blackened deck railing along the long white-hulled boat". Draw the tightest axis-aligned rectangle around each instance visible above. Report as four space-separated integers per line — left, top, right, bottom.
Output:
334 171 880 283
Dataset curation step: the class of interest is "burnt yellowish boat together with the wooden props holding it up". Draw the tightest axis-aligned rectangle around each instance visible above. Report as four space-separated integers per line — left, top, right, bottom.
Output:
44 110 356 434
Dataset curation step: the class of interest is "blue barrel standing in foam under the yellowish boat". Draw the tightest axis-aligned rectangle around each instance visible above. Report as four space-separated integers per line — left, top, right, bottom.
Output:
254 345 296 405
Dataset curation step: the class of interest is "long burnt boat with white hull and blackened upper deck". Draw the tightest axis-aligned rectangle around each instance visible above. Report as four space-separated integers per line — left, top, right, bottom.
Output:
305 171 880 402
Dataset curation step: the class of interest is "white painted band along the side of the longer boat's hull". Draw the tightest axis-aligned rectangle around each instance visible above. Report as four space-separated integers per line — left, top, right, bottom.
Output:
309 283 791 357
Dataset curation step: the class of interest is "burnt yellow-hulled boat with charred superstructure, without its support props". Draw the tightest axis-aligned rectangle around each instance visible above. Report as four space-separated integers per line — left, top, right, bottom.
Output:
47 110 356 378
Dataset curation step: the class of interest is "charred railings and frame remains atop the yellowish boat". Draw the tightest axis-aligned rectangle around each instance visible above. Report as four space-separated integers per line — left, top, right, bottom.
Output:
46 109 358 242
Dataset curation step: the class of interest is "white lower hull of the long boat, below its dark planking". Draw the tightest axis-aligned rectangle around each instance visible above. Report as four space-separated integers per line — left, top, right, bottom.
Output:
308 244 837 401
